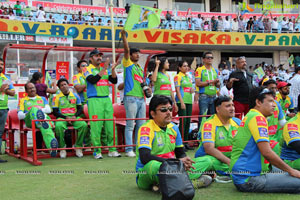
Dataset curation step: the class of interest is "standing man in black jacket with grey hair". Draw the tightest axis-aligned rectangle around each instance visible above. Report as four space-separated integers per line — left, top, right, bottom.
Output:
227 57 253 117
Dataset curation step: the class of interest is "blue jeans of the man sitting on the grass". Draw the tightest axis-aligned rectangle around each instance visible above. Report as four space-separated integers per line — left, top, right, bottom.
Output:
235 166 300 193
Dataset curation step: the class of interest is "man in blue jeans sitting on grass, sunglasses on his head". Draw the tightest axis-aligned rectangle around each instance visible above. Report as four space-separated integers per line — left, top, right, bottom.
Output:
230 87 300 193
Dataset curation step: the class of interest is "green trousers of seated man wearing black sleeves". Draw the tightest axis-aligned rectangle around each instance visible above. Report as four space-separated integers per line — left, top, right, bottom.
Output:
55 118 88 148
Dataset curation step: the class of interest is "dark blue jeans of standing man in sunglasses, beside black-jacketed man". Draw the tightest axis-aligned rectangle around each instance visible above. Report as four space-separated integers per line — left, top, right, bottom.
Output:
199 94 216 127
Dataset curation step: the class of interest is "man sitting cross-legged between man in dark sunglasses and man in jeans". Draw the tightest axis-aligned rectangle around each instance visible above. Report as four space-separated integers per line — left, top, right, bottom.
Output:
193 96 240 179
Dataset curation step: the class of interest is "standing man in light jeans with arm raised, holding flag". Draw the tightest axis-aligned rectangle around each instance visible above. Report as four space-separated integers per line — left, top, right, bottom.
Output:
121 30 151 157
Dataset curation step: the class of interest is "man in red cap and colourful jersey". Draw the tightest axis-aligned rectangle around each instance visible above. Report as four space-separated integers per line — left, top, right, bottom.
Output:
276 81 296 120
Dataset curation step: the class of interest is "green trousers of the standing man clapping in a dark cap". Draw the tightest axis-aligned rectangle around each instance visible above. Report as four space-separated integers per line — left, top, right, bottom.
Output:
88 98 118 153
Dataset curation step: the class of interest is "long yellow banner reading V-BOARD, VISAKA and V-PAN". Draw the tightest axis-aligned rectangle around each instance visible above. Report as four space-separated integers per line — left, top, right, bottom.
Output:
0 19 300 47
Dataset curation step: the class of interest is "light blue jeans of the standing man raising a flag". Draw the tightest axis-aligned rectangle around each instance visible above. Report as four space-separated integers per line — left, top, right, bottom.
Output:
123 96 146 152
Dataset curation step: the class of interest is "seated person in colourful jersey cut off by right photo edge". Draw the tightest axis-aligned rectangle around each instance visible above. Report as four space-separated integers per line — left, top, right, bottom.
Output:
280 95 300 170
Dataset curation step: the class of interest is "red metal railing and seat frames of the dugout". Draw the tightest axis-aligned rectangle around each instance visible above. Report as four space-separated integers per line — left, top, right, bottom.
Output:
4 103 239 165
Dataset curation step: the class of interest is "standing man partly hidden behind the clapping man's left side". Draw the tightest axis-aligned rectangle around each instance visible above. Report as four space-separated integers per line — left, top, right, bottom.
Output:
72 60 88 105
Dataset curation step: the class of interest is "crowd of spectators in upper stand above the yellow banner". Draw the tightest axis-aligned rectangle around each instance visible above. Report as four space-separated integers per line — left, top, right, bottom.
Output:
0 1 300 33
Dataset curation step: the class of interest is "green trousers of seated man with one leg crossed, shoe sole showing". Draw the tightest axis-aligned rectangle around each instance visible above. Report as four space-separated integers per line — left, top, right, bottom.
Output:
24 107 55 149
